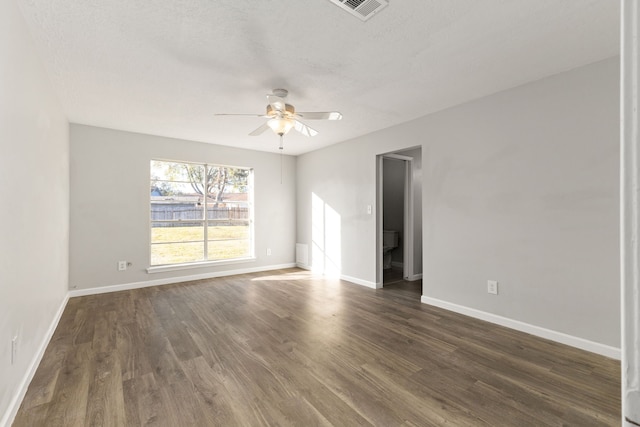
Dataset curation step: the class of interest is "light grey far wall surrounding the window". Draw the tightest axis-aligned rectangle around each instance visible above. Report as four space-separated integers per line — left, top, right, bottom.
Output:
70 124 296 289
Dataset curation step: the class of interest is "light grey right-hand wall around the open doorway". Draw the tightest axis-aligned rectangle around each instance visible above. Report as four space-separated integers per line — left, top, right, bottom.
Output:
297 58 620 348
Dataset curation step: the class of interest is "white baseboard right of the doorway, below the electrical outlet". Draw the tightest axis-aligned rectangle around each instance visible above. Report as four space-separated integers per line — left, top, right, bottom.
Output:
420 295 622 360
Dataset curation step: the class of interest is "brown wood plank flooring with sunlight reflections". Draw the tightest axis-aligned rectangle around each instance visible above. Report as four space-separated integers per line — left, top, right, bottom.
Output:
13 269 620 427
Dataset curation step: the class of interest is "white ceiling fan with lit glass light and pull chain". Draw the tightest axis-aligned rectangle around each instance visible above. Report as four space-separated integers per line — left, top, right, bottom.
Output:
215 89 342 142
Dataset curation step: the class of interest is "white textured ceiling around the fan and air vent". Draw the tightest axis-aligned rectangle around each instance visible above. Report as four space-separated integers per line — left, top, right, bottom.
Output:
16 0 619 155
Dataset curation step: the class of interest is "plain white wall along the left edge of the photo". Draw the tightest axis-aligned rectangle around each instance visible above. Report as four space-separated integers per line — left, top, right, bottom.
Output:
0 1 69 425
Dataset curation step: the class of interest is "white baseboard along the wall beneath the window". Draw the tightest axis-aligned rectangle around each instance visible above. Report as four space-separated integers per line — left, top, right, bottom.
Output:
69 263 296 297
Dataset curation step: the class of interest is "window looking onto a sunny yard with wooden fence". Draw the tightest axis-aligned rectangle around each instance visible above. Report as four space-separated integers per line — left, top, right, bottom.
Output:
150 160 253 267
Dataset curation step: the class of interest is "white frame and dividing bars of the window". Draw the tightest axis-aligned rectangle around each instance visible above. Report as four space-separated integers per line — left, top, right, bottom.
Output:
147 158 256 273
